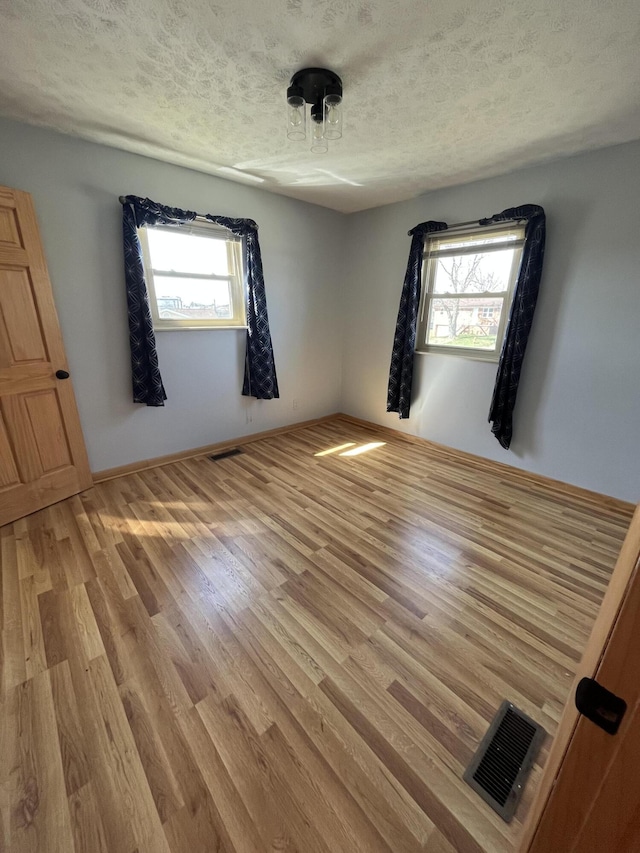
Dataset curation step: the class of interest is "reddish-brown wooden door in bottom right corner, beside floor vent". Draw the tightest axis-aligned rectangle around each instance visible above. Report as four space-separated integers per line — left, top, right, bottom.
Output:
520 507 640 853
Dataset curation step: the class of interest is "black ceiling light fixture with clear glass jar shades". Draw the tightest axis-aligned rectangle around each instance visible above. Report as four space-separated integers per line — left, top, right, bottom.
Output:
287 68 342 154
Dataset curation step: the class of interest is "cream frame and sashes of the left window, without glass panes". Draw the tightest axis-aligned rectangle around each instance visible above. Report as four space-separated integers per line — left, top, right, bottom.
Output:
138 221 247 332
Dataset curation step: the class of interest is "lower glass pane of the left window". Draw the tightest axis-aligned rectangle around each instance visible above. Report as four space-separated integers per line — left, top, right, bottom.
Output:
153 273 233 320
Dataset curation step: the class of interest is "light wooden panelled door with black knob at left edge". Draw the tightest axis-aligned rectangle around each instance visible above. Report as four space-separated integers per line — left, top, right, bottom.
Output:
0 187 92 525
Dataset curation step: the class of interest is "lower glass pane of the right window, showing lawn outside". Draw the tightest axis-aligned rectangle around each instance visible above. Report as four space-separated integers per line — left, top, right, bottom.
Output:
427 297 504 350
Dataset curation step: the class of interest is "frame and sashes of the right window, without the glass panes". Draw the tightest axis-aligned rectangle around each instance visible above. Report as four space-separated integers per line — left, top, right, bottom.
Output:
415 221 525 362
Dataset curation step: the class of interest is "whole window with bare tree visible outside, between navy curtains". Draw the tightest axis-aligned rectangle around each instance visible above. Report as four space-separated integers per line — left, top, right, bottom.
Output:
416 223 524 361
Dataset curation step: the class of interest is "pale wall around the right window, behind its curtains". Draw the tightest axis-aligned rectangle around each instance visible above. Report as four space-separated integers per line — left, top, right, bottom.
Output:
343 143 640 501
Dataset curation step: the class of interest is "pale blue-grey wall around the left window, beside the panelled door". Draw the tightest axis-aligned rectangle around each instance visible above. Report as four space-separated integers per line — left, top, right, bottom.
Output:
0 121 344 471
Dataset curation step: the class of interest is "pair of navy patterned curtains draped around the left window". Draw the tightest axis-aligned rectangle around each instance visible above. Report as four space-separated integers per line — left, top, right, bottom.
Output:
122 195 280 406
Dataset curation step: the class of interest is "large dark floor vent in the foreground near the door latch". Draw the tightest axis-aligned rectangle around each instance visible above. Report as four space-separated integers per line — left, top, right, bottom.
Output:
462 701 546 823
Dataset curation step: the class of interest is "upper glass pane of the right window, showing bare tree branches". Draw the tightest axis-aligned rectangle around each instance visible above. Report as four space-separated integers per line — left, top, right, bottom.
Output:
431 249 514 293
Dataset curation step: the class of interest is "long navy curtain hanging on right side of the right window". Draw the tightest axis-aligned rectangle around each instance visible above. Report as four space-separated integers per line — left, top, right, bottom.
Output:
480 204 546 450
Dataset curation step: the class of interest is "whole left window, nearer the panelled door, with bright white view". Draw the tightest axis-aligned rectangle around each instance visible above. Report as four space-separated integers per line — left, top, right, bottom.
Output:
138 223 246 331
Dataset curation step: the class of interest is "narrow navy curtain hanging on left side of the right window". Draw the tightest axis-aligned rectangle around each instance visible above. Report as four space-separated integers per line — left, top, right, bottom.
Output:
387 221 447 418
